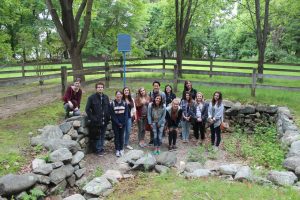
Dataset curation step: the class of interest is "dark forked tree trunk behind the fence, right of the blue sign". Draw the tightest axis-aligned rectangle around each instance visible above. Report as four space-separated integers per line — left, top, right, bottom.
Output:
175 0 198 78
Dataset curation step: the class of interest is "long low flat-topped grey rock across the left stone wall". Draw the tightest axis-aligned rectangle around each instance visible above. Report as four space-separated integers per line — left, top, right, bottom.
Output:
44 139 81 154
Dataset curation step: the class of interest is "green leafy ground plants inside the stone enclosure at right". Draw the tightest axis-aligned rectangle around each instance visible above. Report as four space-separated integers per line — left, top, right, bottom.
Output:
224 125 286 169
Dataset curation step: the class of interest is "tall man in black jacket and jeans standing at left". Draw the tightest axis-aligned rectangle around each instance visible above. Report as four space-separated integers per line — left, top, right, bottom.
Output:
85 82 110 156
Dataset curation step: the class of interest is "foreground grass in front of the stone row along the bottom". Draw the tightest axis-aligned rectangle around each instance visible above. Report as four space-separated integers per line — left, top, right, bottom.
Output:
108 173 300 200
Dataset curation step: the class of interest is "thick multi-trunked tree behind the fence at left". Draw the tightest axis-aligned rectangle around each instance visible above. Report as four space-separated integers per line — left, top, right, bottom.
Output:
46 0 93 81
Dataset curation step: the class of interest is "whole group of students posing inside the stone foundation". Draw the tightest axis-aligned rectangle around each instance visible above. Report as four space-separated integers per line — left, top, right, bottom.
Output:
64 79 224 157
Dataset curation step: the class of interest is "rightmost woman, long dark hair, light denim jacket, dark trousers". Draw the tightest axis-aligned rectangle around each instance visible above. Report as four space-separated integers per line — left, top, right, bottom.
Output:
208 92 224 150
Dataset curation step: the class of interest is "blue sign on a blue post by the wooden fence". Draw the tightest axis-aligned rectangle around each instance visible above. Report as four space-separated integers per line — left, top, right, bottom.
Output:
118 34 131 87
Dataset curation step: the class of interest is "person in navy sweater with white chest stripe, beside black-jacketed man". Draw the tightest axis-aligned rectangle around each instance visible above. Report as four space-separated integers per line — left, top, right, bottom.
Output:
110 90 129 157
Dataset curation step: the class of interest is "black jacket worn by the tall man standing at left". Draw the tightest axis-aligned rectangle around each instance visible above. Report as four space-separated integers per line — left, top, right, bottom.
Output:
85 93 110 126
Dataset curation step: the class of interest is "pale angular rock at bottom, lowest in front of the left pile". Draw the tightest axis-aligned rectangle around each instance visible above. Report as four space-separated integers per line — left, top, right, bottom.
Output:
83 177 112 196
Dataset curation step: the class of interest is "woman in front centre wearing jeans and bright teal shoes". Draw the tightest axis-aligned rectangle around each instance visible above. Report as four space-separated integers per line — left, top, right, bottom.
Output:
147 95 166 155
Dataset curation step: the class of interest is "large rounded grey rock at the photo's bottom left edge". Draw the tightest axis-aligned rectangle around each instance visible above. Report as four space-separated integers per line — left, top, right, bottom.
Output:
0 174 37 196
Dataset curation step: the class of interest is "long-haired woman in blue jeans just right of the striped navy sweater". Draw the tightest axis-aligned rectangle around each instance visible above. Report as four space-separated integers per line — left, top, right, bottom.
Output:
122 87 136 150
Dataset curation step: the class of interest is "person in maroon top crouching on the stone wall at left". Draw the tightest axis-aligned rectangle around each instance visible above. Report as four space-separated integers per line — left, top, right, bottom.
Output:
63 78 82 118
